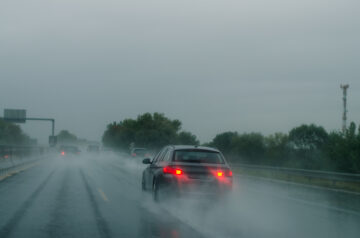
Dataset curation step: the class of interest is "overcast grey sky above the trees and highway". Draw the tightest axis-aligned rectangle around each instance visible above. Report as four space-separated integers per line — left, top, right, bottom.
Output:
0 0 360 142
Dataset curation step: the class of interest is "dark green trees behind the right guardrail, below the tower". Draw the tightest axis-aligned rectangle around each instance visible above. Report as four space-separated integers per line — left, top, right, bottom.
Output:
207 122 360 173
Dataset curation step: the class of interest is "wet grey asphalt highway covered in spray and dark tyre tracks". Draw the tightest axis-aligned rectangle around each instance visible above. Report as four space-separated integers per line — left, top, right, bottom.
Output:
0 154 360 238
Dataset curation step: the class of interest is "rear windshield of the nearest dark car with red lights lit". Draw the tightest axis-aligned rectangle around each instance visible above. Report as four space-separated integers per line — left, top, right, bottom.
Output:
173 150 224 164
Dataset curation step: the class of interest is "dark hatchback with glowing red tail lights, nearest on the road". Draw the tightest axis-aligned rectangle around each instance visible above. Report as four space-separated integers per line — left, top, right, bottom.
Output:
142 145 233 202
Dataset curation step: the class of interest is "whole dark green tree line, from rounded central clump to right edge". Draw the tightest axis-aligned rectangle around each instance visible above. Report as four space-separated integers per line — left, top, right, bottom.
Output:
102 113 360 173
